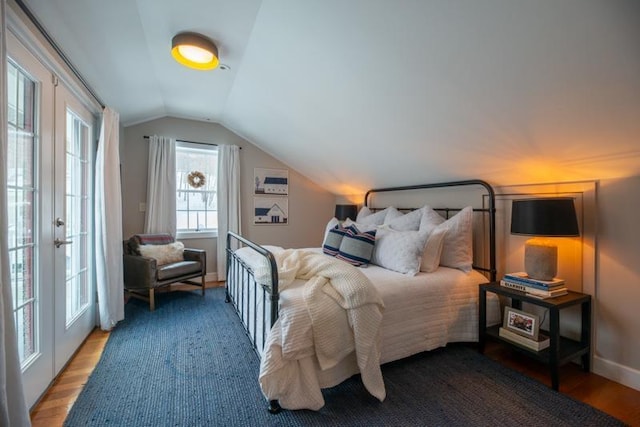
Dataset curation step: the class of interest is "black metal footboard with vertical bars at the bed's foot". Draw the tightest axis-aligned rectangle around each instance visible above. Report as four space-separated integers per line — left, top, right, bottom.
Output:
225 231 279 356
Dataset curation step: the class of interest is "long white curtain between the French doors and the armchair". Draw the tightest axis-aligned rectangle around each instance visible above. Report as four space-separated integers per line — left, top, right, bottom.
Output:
95 107 124 331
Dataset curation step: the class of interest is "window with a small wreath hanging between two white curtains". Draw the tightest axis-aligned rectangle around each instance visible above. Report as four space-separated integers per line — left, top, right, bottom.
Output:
176 141 218 238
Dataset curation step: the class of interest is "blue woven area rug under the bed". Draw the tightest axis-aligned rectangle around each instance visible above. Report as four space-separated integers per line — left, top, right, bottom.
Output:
65 288 623 427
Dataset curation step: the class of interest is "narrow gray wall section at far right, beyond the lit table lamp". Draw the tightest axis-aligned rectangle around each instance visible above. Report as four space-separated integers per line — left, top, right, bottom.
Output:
594 176 640 382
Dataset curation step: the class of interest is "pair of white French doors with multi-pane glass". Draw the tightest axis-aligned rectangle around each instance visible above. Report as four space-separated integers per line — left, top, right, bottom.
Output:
7 32 95 406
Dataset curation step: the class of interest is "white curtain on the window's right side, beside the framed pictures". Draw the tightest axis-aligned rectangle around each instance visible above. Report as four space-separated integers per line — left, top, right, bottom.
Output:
217 145 240 280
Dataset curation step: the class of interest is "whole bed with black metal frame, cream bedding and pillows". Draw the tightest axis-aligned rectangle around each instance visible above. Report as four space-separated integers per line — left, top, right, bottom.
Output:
226 180 500 412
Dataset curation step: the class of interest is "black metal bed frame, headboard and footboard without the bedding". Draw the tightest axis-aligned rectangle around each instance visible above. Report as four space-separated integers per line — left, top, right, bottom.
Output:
225 180 496 413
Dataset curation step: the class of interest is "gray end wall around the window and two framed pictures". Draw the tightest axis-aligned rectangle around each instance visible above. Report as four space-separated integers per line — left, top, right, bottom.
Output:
120 118 335 273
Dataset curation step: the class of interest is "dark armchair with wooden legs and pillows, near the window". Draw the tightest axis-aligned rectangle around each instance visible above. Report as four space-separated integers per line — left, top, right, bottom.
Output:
123 234 207 311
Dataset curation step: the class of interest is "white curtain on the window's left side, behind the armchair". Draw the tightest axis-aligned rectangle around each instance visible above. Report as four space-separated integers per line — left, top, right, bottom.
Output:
144 135 176 237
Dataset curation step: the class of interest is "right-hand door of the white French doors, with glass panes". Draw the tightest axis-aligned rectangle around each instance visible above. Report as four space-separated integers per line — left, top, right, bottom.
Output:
52 85 96 373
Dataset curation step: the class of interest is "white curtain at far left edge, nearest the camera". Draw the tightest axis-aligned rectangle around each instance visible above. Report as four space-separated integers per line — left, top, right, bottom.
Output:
0 0 31 427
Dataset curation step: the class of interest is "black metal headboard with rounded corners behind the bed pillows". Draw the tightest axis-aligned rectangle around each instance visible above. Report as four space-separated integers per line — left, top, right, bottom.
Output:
364 179 496 281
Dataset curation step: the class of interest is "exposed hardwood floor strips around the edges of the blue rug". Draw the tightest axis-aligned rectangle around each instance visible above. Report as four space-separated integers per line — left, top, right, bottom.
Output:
31 290 640 427
